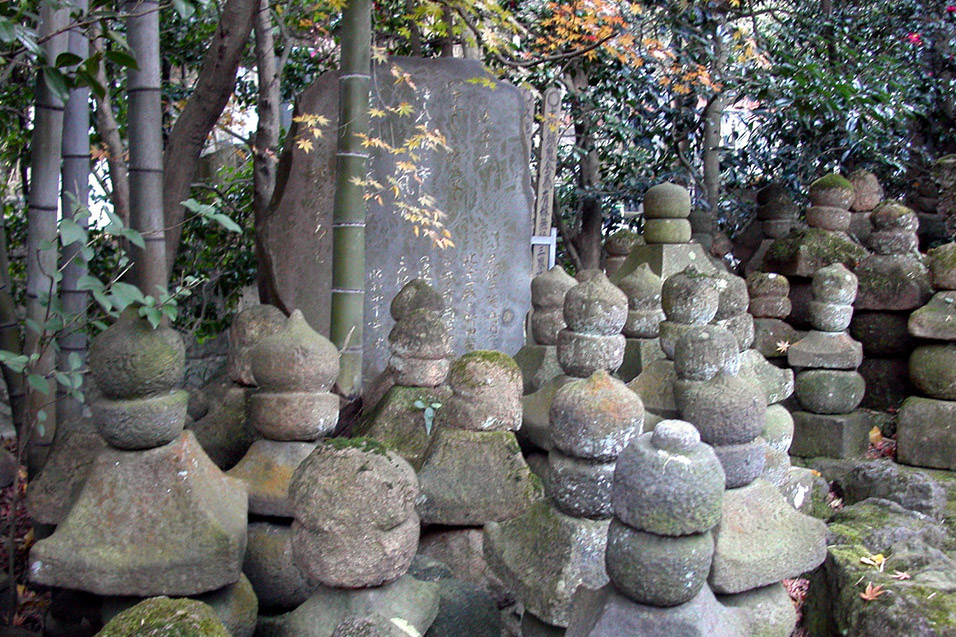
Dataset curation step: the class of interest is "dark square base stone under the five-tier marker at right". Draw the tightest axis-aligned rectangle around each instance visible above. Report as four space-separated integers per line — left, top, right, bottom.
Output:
790 410 872 458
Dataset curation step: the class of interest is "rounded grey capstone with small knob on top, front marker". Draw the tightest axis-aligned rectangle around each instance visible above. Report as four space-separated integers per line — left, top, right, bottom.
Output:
611 420 724 536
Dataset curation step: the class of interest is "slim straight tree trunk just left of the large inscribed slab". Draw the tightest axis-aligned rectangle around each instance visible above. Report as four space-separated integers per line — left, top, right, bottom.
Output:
252 0 289 305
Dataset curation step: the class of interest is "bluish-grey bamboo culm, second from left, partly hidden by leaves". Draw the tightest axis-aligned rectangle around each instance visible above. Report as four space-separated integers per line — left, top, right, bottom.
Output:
56 0 90 427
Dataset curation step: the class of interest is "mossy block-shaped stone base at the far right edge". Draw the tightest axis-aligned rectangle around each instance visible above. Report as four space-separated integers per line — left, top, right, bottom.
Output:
896 396 956 471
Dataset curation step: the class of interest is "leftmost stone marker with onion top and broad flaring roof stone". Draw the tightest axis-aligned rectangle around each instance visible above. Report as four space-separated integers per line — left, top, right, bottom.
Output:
30 310 252 620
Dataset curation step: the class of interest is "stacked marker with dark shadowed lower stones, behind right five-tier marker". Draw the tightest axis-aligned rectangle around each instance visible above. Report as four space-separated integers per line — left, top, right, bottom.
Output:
850 201 933 410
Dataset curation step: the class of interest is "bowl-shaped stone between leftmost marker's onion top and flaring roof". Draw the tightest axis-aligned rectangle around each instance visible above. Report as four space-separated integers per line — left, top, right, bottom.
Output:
90 389 189 449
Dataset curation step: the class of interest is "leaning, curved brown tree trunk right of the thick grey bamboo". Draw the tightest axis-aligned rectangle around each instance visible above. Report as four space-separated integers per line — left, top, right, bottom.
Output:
157 0 259 272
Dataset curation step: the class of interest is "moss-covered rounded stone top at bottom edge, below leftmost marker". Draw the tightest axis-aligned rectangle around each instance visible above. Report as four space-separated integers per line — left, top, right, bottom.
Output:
97 597 229 637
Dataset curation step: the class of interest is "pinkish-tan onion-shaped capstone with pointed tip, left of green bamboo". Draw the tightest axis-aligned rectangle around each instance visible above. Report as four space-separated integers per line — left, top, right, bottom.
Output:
250 310 339 392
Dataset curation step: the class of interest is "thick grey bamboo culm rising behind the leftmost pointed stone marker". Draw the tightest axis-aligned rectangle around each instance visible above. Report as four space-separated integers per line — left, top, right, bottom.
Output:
123 0 167 296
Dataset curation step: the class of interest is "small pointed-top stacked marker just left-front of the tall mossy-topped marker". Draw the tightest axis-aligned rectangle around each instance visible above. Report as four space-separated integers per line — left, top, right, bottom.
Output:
618 263 664 383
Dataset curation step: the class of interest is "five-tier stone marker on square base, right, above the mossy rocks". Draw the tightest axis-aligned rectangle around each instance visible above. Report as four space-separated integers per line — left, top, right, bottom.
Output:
787 263 870 458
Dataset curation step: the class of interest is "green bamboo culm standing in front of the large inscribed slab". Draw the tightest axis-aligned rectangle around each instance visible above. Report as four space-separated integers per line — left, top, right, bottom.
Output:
331 0 372 400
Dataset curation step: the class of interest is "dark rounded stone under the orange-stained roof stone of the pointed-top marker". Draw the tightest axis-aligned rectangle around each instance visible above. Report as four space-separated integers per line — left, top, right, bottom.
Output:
242 522 315 610
